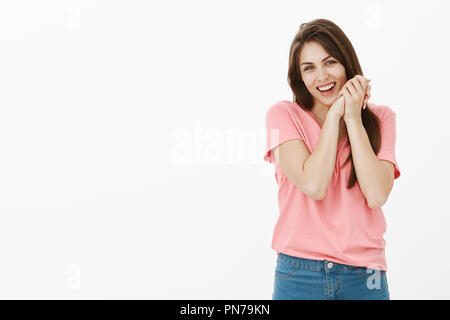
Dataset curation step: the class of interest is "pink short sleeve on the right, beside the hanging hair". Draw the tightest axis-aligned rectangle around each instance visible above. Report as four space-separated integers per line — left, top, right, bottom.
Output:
377 108 400 179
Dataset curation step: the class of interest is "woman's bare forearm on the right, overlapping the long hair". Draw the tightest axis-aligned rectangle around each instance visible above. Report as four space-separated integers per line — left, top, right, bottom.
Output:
346 119 389 207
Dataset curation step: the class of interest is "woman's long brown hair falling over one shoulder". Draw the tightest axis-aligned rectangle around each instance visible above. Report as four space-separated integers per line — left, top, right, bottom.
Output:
288 19 381 189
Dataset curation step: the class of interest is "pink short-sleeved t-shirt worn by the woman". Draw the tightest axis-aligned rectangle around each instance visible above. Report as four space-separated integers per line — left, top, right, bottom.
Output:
264 100 400 271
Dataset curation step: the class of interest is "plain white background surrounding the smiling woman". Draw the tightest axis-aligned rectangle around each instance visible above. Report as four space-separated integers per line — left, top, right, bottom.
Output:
0 0 450 299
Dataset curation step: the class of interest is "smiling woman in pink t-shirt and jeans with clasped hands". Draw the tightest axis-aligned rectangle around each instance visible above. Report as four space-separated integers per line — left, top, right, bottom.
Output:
264 19 400 300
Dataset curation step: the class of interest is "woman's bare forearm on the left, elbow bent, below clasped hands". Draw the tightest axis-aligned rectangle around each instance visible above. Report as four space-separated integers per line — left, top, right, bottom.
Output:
303 113 340 199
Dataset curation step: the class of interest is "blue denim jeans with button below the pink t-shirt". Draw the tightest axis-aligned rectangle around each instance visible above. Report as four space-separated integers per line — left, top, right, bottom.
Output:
272 252 390 300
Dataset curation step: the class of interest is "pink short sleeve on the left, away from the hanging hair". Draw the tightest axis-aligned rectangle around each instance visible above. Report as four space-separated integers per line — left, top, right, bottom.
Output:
264 103 304 163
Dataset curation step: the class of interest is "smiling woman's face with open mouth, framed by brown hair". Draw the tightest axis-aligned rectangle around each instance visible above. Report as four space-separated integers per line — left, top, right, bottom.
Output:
299 41 347 106
